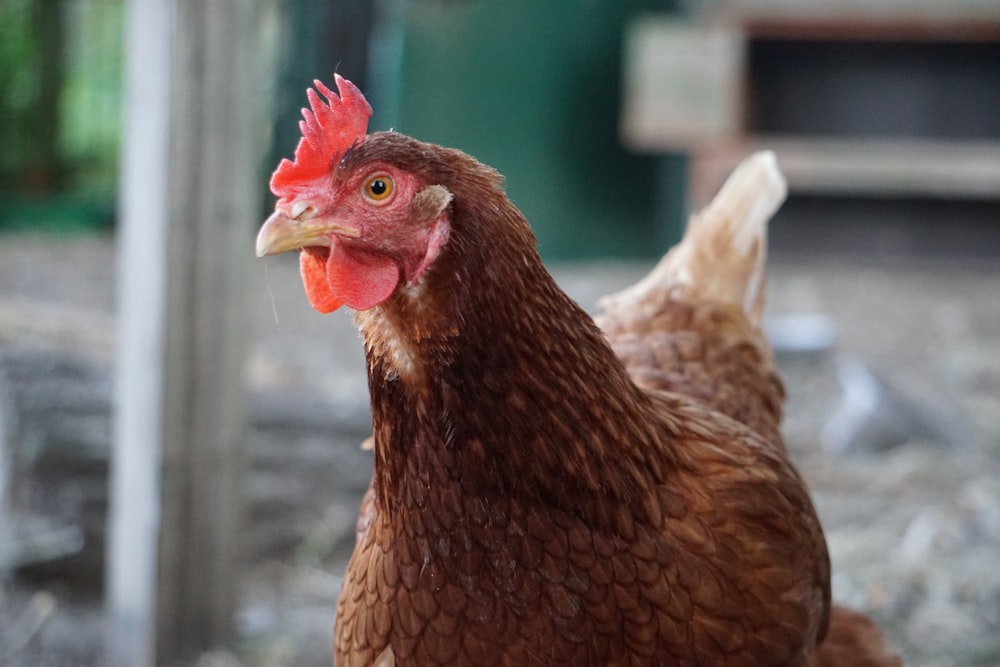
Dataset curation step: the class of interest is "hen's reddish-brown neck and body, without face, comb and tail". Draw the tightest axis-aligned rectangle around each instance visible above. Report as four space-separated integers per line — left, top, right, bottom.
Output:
336 135 828 665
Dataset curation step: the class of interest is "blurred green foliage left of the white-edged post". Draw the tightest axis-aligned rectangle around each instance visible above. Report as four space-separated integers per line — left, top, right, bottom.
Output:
0 0 123 226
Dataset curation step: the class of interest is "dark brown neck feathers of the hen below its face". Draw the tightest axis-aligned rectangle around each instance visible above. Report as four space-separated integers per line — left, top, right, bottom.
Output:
358 188 663 523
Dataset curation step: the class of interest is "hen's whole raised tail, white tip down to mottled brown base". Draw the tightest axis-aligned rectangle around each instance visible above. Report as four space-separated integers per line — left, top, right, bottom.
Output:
596 152 786 440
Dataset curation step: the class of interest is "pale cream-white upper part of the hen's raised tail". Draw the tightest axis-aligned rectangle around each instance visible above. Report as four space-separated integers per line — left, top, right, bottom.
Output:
601 151 788 326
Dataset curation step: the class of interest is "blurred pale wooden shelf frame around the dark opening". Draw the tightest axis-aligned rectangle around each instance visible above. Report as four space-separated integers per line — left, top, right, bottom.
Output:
621 13 1000 207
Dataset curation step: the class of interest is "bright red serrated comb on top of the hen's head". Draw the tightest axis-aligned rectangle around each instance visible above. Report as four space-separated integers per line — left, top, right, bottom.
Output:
271 74 372 198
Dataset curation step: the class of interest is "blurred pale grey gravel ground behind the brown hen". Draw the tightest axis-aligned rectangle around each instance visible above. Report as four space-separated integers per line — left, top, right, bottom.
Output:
0 236 1000 667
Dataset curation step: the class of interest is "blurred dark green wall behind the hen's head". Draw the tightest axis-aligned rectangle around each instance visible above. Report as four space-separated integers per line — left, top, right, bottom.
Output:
372 0 684 259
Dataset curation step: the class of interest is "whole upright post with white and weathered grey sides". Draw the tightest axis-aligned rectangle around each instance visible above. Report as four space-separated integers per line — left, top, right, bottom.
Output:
107 0 268 667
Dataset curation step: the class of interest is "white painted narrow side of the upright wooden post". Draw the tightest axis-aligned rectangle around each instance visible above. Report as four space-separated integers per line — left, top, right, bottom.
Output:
106 0 174 667
